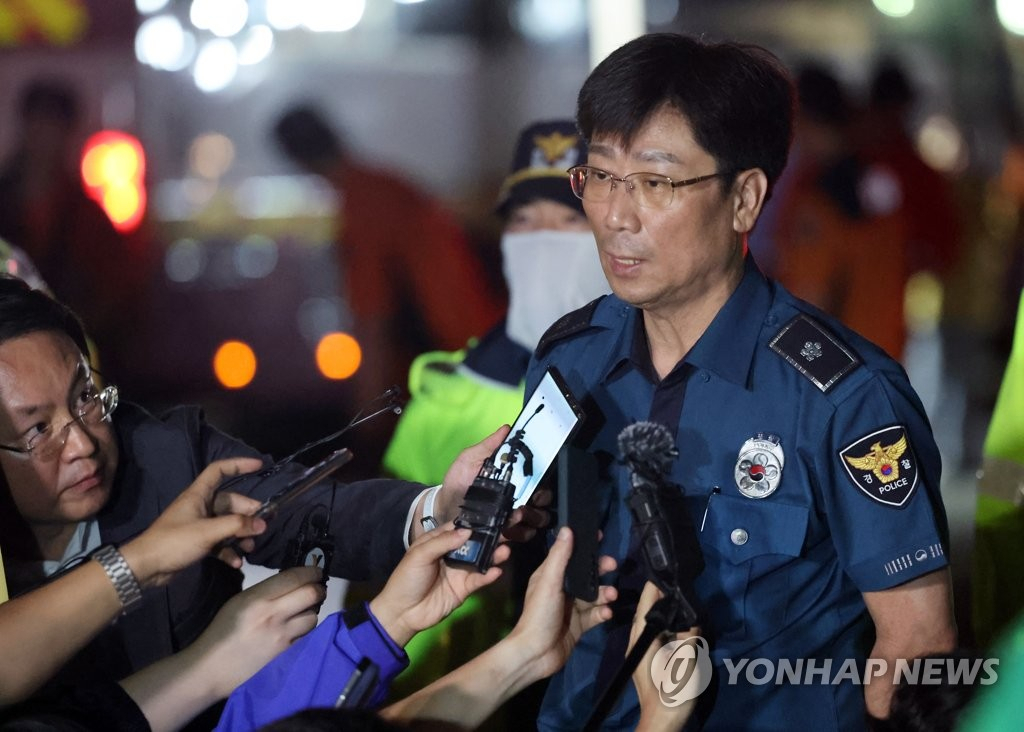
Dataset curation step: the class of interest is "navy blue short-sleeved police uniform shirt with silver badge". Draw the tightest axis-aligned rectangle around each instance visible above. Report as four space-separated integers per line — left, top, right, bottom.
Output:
526 256 948 730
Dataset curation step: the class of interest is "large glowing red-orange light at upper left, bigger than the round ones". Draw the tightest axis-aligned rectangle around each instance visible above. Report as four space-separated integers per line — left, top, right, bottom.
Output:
82 130 145 231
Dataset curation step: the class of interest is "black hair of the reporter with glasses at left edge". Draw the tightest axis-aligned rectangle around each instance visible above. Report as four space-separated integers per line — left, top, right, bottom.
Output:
0 274 89 357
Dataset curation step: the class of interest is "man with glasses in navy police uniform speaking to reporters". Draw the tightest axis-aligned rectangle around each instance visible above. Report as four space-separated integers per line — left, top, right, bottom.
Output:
526 34 956 730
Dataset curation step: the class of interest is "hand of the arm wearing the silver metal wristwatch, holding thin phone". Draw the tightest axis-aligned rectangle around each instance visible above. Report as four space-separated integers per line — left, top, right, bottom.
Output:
121 458 266 587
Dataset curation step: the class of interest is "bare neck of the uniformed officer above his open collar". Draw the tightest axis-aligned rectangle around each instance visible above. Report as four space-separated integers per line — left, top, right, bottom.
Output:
643 267 743 379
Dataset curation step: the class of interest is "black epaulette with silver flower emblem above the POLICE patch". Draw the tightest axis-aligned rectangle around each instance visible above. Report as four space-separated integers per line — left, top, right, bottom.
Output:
768 313 861 393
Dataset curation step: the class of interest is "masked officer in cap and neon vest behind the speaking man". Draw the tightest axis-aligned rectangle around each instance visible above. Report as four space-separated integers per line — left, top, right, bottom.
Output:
384 120 609 485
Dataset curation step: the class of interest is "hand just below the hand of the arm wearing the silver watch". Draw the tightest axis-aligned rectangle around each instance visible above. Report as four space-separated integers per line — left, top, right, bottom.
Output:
176 567 327 698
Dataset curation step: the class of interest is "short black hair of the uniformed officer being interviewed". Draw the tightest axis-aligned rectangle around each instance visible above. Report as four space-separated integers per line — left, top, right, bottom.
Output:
577 33 796 193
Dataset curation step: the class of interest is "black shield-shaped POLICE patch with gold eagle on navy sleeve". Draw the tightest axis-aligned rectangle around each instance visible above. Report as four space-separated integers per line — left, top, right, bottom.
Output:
839 425 918 508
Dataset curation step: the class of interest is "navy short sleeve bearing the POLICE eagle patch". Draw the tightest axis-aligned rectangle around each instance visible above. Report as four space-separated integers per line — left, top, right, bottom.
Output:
818 375 948 592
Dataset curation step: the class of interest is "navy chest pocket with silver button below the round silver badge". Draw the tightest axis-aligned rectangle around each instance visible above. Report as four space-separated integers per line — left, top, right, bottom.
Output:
696 493 809 642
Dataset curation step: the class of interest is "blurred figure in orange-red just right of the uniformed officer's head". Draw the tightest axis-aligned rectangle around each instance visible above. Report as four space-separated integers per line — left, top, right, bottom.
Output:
773 64 909 360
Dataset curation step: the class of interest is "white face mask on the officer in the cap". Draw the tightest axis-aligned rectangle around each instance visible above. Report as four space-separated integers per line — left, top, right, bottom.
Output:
502 229 611 351
